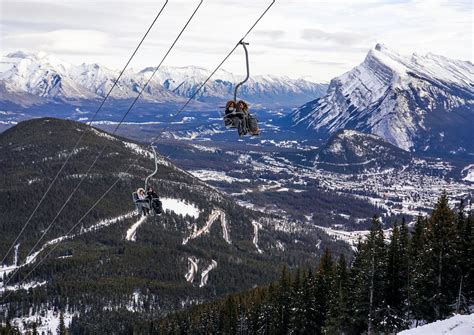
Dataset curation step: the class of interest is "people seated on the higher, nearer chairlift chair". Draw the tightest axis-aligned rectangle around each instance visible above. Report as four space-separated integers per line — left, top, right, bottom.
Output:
224 100 260 136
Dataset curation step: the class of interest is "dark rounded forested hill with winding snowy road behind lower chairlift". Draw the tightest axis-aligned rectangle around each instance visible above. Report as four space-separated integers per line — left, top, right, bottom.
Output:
0 118 348 326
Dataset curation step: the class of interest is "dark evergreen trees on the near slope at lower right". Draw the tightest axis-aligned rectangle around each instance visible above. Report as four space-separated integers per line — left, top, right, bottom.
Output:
104 194 474 335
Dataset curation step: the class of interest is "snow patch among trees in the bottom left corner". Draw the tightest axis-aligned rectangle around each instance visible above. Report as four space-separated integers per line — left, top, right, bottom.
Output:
11 310 74 334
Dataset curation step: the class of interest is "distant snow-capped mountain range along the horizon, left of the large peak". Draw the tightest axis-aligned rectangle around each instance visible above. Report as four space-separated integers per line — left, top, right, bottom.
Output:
0 51 327 107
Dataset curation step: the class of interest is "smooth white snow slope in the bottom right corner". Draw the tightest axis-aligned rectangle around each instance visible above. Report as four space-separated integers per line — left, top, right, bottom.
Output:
398 314 474 335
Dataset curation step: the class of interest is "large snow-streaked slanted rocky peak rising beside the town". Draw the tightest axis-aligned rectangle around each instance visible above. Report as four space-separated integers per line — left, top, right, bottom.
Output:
292 44 474 153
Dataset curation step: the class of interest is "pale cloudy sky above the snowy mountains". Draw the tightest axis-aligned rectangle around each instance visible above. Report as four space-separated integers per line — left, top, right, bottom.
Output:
0 0 473 82
